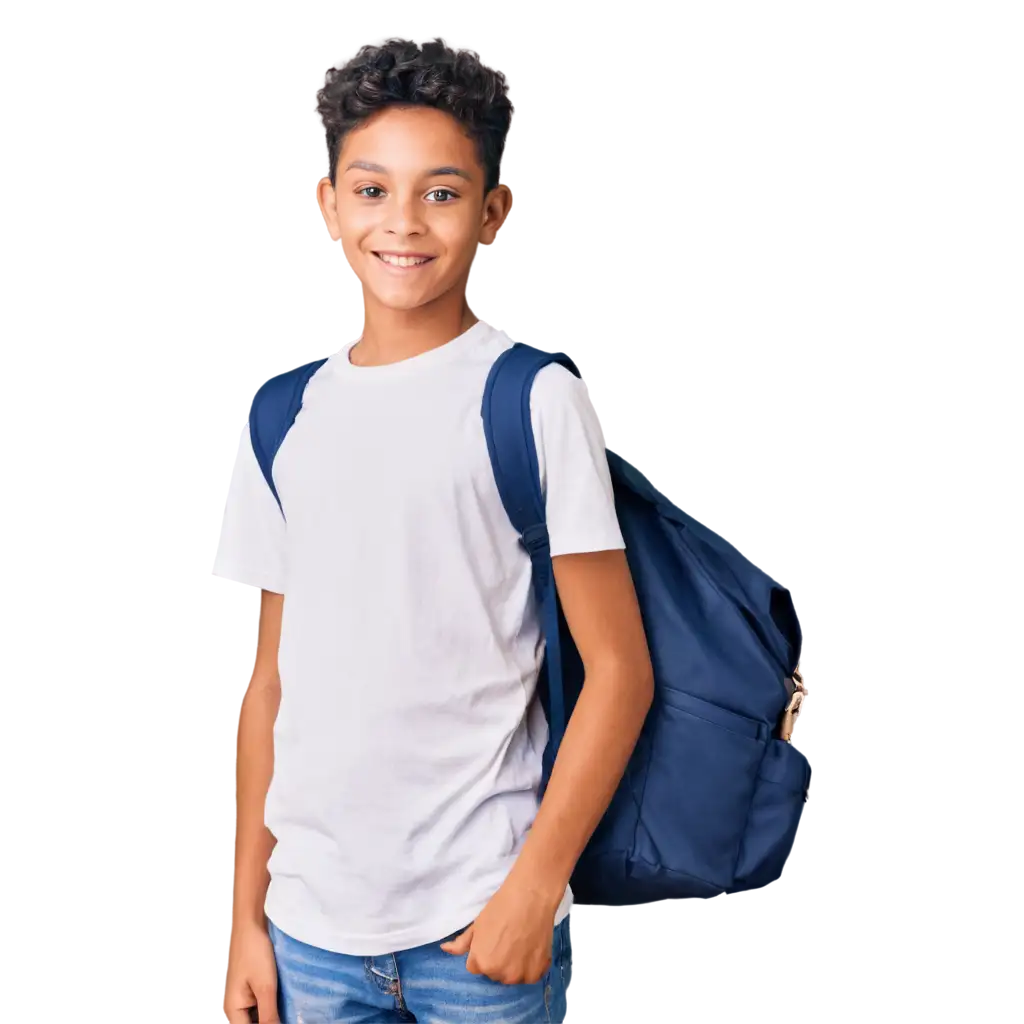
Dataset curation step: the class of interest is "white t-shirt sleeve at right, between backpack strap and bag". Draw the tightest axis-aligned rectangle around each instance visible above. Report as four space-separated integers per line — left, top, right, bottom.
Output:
530 364 626 556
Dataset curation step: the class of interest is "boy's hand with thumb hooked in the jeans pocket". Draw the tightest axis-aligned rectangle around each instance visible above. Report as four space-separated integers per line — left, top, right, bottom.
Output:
441 876 560 985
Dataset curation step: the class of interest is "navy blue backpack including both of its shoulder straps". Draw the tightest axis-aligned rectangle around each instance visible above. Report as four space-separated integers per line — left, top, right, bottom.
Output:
249 343 810 908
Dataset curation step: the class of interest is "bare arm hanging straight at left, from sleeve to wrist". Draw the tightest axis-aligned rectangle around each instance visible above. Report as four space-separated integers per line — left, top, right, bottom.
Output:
231 590 285 930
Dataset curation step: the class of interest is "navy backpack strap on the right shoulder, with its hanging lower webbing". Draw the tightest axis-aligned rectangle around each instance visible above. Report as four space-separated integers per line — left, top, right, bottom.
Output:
481 342 583 761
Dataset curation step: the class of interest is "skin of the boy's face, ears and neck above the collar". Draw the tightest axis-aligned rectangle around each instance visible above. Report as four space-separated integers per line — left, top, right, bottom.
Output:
313 108 508 366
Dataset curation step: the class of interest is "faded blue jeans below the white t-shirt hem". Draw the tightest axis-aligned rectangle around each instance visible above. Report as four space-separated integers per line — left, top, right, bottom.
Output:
268 916 571 1024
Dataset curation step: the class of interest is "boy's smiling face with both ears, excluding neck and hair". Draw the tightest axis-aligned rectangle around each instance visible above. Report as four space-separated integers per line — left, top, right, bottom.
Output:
316 106 508 310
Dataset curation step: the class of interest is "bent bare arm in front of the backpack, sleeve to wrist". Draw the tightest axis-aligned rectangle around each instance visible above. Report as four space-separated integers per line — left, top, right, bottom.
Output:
514 551 654 911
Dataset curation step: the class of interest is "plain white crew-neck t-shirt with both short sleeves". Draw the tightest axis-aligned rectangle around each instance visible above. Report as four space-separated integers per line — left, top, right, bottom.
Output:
209 321 625 956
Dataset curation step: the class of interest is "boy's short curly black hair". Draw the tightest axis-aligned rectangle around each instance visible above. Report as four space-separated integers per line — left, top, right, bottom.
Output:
313 35 511 194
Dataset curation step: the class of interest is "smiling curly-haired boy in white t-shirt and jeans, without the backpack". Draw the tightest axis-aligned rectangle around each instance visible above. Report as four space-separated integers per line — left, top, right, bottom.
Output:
211 39 652 1024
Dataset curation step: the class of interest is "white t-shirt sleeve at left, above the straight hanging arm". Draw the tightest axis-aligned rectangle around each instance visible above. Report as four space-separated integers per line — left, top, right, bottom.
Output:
207 423 286 594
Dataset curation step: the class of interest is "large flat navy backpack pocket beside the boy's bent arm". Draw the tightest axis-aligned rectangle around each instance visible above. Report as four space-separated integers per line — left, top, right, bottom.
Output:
632 689 769 896
